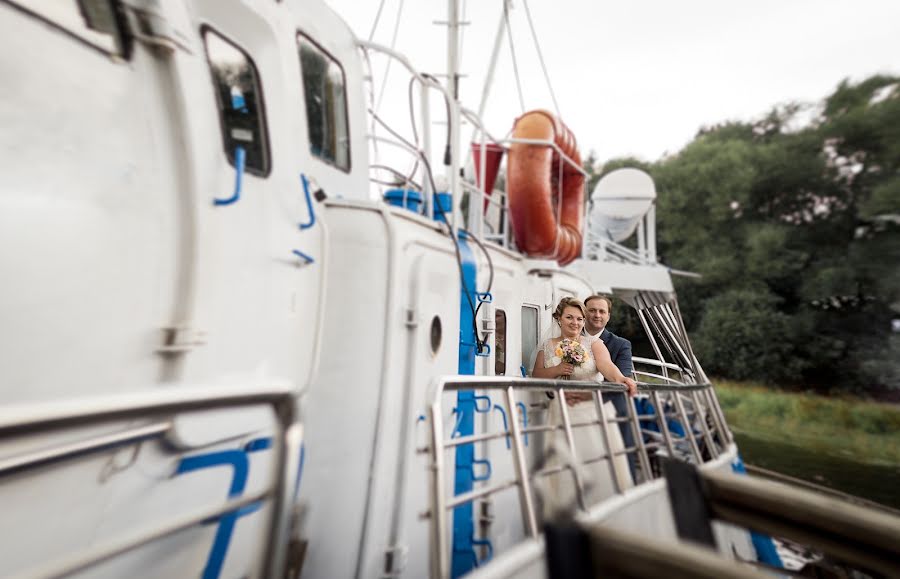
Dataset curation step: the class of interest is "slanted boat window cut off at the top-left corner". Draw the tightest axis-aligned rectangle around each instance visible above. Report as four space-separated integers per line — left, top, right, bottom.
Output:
9 0 124 55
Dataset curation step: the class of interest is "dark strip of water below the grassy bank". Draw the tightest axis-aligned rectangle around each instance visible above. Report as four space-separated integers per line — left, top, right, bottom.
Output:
734 432 900 509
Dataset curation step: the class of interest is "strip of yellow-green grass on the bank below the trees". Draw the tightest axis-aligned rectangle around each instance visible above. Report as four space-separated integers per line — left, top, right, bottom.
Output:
713 380 900 464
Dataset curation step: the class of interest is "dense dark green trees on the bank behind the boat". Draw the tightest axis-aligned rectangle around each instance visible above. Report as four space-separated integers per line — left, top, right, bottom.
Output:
595 76 900 391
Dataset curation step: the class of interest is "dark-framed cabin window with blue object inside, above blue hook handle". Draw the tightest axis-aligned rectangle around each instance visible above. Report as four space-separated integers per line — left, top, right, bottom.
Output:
203 28 269 176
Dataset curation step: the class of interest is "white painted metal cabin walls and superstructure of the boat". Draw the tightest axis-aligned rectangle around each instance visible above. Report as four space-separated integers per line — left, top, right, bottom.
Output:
0 0 748 578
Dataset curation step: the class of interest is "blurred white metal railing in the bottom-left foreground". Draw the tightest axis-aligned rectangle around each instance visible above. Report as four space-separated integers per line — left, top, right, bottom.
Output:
0 387 302 579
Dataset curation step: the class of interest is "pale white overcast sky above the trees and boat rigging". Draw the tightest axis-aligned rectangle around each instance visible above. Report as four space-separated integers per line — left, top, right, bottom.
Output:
326 0 900 160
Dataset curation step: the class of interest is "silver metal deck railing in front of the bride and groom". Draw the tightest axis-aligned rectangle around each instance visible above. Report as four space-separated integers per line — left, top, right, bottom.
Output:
419 376 721 577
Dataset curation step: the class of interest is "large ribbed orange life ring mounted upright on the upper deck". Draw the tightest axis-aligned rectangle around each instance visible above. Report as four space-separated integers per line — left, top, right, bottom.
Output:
507 110 584 265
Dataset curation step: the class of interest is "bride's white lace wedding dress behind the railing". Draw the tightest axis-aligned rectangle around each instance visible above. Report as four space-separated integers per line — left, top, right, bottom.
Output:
541 336 634 515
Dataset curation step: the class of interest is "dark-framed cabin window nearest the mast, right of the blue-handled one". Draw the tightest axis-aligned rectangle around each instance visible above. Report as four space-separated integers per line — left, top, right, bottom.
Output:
297 34 350 171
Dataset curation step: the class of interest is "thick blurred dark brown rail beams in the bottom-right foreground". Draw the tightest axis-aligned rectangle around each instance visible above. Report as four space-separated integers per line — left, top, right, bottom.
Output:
564 463 900 579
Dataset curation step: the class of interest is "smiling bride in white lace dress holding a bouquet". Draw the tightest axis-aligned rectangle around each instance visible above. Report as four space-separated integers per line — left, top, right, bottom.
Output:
532 297 637 514
